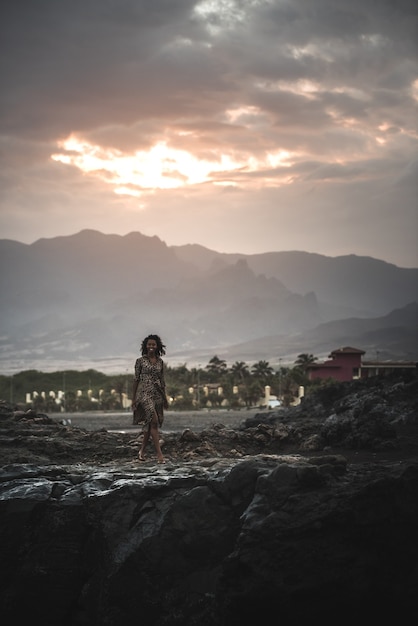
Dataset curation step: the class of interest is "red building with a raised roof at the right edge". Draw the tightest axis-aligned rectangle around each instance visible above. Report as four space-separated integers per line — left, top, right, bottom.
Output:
306 347 417 382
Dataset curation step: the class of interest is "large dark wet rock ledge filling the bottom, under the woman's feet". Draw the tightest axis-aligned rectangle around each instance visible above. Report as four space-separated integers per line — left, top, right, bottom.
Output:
0 455 418 626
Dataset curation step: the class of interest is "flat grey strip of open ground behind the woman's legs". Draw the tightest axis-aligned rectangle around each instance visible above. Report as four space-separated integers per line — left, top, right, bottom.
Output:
55 408 261 432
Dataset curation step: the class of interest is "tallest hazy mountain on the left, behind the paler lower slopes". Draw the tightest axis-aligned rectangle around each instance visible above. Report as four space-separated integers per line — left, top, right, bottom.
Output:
0 230 195 323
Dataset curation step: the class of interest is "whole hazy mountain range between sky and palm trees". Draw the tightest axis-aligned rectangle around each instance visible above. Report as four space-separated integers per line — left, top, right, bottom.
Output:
0 230 418 373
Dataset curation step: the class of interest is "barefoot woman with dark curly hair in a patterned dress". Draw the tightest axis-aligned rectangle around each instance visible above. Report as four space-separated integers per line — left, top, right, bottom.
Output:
132 335 168 463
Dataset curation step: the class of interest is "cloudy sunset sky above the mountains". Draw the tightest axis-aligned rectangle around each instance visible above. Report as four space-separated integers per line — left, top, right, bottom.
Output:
0 0 418 267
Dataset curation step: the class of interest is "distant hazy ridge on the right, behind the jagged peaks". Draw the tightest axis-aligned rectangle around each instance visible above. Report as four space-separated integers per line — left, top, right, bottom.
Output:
175 245 418 319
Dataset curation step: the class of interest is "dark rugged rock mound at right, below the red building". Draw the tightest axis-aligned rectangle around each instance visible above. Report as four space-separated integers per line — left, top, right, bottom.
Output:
244 372 418 456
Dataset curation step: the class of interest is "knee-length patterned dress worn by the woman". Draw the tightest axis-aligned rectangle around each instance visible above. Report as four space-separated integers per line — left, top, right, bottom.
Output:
133 356 166 430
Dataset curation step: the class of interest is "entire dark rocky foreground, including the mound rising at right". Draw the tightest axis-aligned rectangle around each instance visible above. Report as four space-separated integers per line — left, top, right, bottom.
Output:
0 378 418 626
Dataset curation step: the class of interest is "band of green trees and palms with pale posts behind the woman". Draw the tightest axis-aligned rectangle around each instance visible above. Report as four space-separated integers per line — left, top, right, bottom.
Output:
0 354 322 413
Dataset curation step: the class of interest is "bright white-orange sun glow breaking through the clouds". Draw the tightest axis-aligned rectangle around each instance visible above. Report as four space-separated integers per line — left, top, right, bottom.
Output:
51 130 298 191
